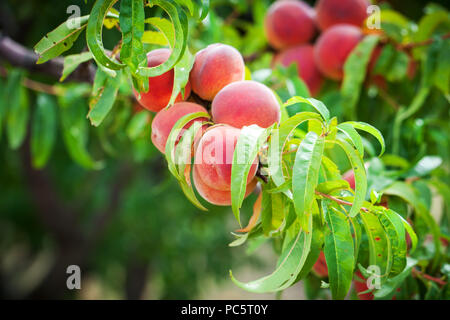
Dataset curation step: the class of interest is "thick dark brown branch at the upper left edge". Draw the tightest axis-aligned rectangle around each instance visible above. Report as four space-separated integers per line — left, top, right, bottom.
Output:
0 34 95 83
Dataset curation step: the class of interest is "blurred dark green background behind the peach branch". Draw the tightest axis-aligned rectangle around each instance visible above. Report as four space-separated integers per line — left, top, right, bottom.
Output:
0 0 449 299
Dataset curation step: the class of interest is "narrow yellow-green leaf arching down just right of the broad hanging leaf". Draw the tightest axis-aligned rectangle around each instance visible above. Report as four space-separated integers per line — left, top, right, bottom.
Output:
334 140 367 218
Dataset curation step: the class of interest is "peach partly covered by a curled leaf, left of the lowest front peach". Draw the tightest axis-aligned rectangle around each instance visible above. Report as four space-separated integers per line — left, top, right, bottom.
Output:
152 102 208 153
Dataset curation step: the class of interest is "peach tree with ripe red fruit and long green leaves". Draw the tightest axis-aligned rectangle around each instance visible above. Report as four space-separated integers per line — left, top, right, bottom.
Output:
0 0 450 299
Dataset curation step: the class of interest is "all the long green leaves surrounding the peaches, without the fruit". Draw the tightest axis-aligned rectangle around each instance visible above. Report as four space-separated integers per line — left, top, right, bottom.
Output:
0 0 450 299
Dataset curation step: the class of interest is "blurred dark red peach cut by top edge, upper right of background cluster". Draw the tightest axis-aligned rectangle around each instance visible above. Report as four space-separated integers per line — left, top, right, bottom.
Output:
316 0 369 30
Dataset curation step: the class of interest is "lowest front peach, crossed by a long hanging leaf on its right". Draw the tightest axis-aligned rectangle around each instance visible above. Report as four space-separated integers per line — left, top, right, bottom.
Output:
193 125 258 205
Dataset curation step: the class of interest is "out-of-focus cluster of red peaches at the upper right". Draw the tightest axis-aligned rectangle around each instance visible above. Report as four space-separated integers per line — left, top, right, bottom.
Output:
265 0 414 96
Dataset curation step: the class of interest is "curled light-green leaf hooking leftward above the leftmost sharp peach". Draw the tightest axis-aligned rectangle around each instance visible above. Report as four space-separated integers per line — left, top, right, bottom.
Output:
139 0 188 77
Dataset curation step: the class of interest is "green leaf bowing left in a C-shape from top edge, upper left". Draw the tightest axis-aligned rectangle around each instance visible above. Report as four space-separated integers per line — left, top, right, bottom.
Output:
86 0 125 74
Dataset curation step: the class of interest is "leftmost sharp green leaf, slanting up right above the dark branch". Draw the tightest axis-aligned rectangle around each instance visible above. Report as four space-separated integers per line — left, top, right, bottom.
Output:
34 16 89 63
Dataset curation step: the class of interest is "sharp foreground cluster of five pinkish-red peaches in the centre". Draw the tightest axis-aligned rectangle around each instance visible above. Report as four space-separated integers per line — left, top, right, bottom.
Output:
135 44 280 205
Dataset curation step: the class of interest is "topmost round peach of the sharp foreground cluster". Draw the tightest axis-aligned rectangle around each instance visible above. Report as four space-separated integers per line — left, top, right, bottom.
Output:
189 43 245 101
